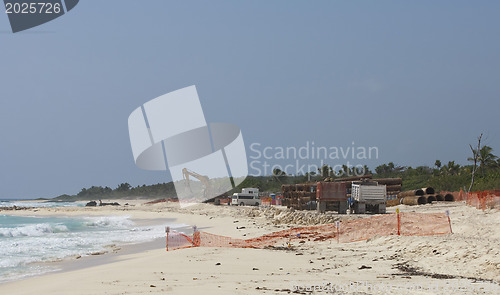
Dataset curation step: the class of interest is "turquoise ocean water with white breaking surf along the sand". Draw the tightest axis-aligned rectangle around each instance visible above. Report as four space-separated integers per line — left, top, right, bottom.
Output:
0 215 185 283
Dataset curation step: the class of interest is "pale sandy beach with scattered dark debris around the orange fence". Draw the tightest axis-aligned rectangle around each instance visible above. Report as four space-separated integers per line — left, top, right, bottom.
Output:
0 200 500 295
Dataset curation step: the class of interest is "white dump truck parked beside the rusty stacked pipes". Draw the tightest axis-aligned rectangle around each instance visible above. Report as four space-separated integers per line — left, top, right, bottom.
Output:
350 181 387 214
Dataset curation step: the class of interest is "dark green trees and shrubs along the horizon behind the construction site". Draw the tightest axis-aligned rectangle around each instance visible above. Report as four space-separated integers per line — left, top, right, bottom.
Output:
52 146 500 201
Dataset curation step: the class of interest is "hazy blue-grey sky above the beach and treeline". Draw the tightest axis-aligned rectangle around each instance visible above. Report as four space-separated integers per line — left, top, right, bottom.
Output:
0 0 500 198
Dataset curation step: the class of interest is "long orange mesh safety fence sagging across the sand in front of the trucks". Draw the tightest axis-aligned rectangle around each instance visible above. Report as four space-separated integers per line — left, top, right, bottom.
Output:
167 212 451 250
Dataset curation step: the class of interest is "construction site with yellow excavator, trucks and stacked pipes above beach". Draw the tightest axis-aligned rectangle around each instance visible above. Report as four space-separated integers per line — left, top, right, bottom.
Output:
194 169 500 214
